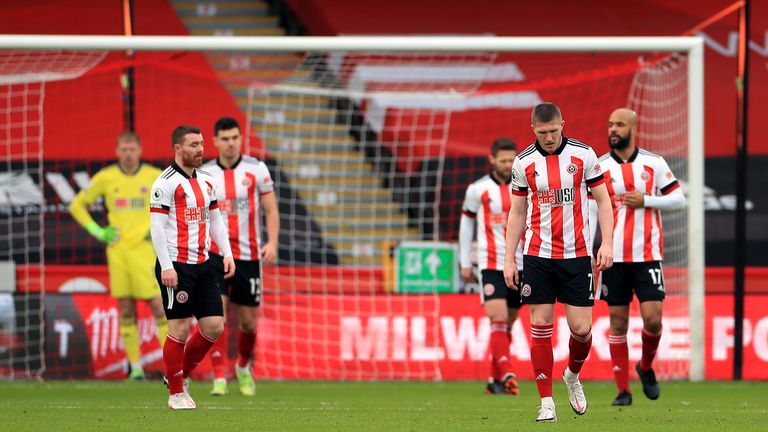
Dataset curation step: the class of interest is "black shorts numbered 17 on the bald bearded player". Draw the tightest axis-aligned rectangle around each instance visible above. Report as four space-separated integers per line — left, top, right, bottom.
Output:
600 261 665 306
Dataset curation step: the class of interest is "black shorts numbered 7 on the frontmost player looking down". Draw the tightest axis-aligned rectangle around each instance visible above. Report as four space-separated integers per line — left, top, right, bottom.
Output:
520 255 595 306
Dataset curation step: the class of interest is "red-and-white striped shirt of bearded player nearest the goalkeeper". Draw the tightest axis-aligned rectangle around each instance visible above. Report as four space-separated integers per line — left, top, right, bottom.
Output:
149 162 218 264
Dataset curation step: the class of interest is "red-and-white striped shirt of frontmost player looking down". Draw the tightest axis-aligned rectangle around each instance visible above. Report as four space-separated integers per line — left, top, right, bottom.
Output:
512 136 604 259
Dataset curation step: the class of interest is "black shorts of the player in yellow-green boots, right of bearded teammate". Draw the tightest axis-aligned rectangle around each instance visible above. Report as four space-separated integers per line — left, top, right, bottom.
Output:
208 254 261 307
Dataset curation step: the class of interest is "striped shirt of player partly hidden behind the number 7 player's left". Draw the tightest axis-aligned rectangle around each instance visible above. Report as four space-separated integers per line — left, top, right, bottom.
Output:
461 174 523 270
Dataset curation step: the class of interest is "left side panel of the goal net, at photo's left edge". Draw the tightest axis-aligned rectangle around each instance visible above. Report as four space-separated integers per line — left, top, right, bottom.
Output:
0 51 105 378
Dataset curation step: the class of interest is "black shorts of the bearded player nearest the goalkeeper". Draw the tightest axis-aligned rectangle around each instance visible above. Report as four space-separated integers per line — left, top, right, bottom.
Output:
155 260 224 320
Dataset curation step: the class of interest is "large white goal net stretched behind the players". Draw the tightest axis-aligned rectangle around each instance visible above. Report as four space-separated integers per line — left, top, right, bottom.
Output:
0 38 704 380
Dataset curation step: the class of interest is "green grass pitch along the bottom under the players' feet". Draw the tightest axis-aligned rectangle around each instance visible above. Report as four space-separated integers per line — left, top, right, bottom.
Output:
0 381 768 432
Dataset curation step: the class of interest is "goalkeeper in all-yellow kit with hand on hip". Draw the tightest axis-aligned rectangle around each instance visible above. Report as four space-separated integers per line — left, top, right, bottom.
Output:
69 132 168 379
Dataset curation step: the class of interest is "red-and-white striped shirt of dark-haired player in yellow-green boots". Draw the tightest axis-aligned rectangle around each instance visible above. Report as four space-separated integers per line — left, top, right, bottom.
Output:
203 156 273 261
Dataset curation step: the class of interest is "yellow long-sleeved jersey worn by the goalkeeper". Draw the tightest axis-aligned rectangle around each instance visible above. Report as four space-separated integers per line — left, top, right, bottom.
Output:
69 163 162 247
